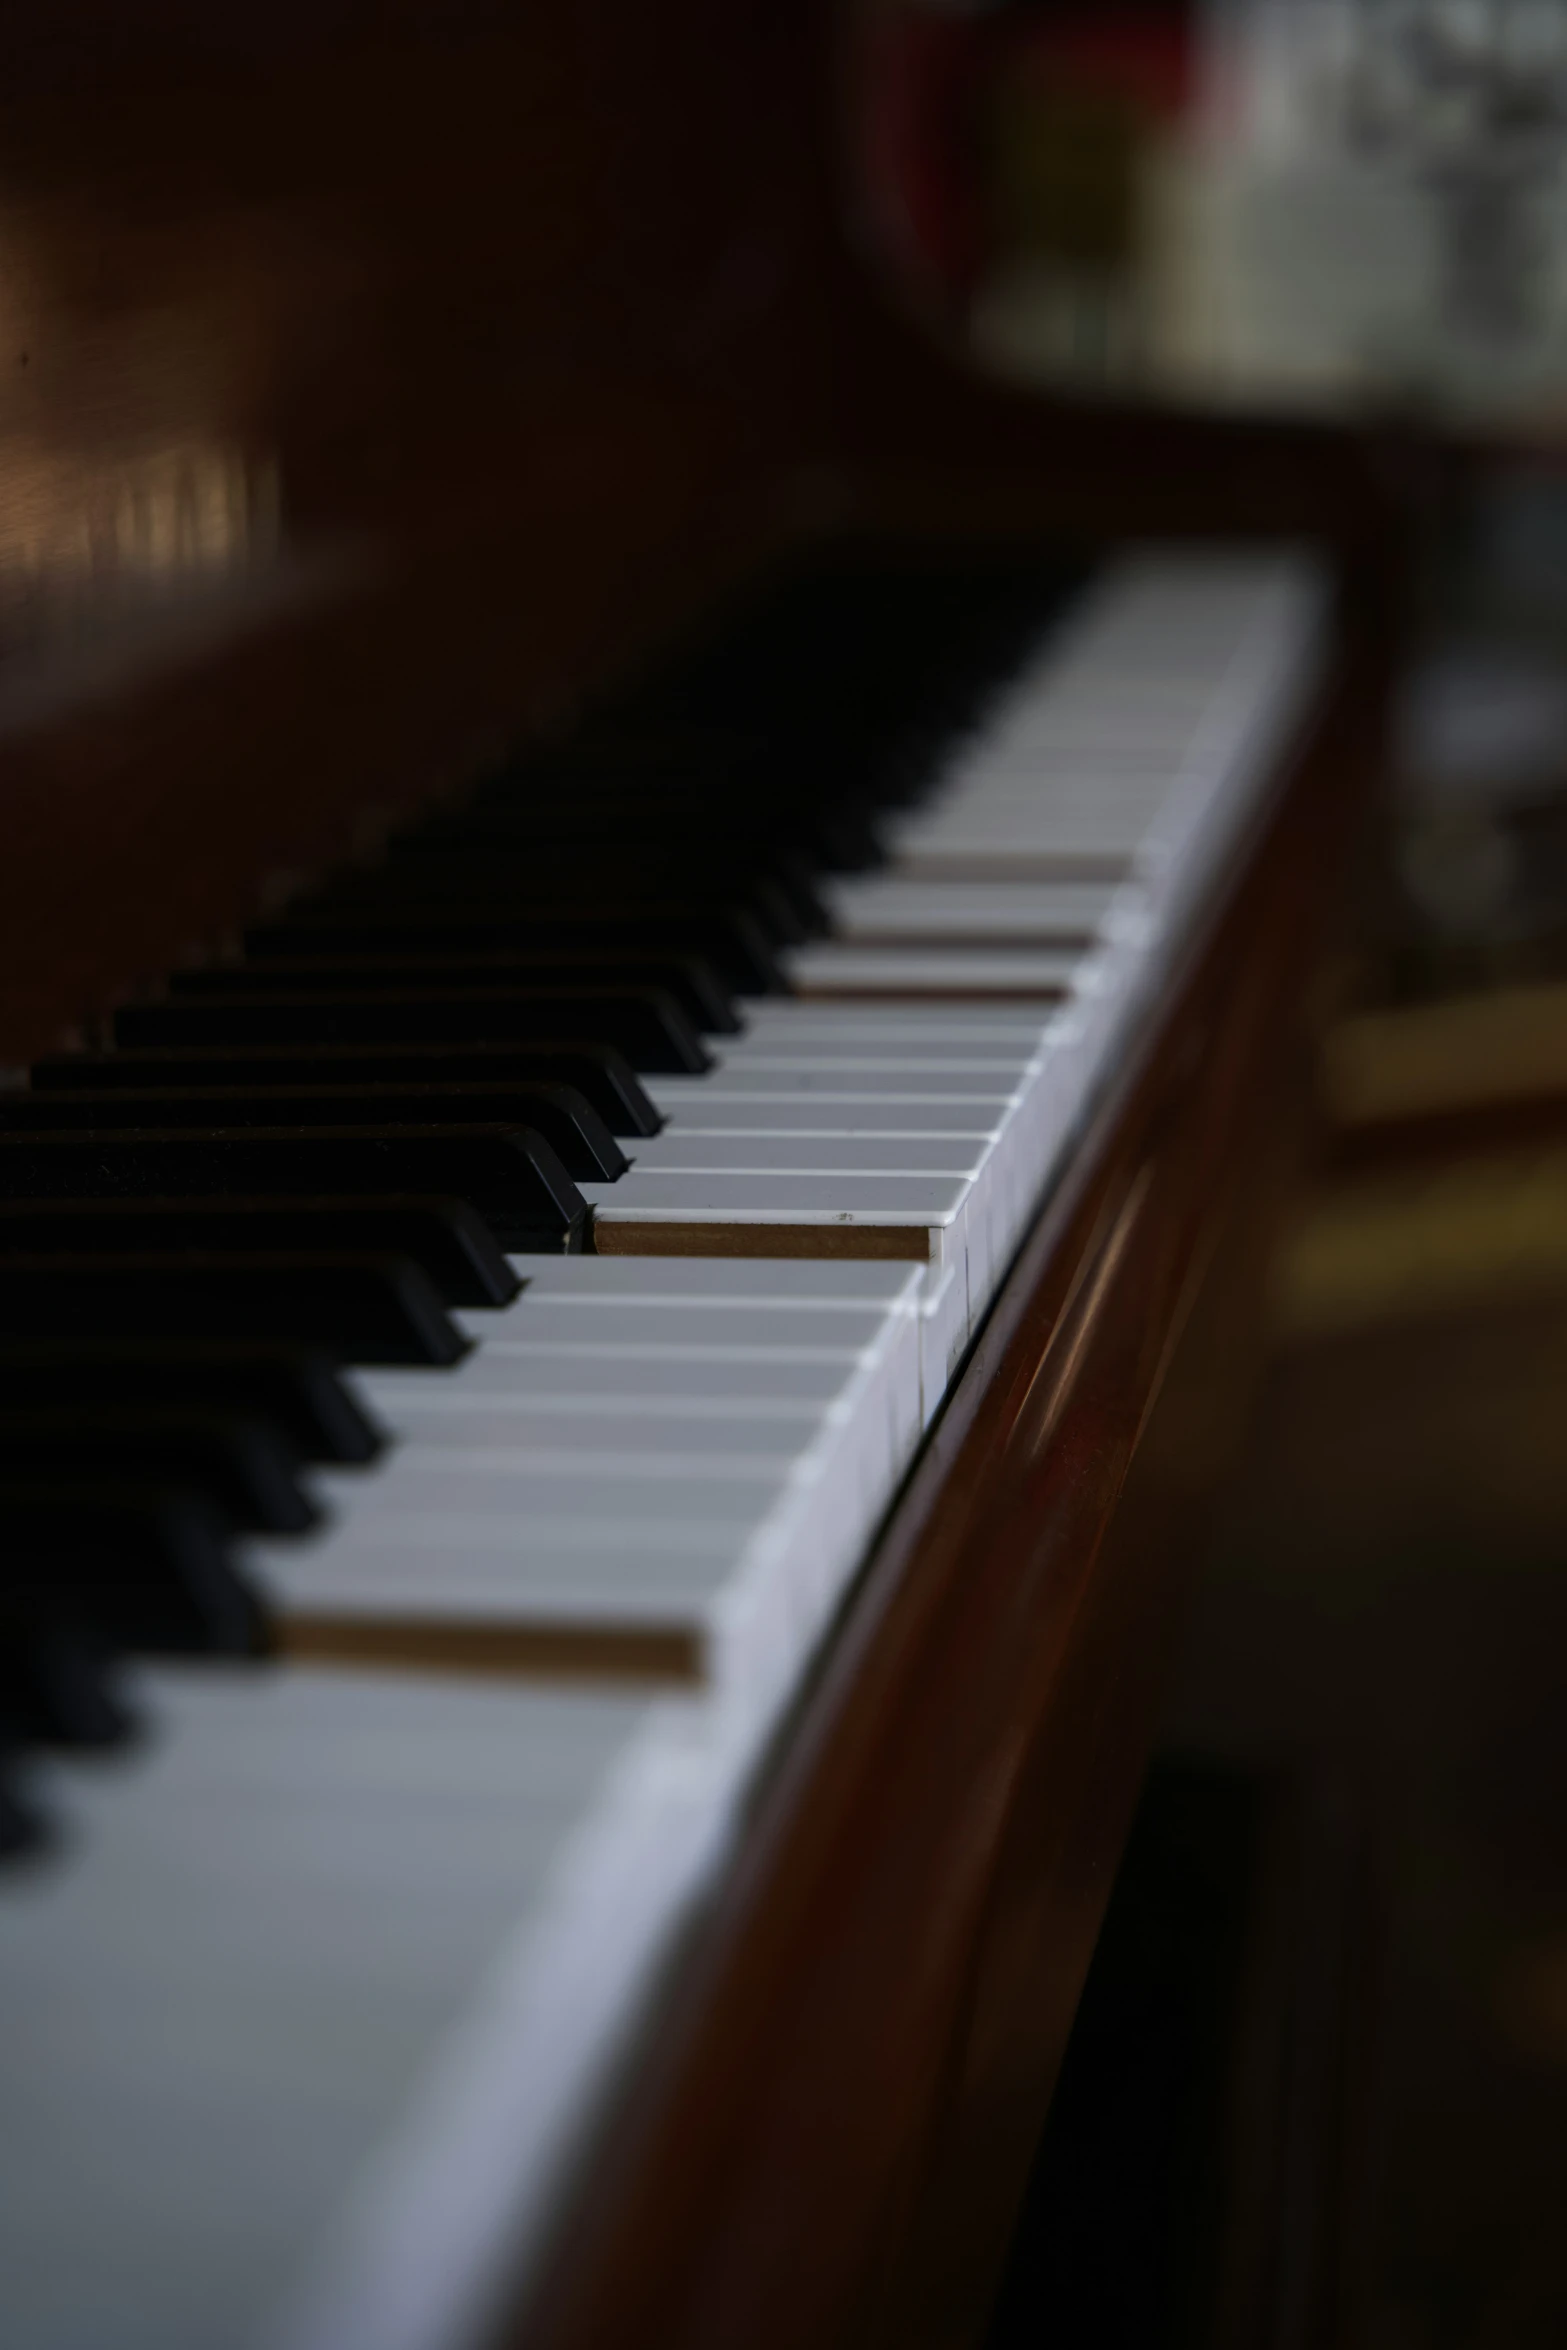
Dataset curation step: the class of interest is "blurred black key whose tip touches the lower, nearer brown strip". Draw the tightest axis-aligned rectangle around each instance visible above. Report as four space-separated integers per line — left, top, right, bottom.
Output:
0 1478 268 1657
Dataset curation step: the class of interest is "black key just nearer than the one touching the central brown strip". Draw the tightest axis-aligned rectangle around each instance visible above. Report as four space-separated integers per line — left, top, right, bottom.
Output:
0 1203 522 1307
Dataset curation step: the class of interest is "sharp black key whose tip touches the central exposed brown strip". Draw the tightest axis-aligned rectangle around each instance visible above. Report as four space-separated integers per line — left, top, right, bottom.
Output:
0 1126 587 1253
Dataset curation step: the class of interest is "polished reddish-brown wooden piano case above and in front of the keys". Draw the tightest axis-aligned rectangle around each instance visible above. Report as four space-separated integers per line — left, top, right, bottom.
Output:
0 0 1386 2350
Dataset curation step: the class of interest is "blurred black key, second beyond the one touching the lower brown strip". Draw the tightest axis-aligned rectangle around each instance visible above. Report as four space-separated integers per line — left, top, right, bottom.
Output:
0 1335 383 1466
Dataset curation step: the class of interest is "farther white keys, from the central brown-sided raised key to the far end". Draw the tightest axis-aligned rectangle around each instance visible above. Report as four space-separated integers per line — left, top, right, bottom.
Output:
585 555 1320 1396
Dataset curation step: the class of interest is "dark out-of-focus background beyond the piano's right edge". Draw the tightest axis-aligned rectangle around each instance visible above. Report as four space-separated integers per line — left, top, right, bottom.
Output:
860 0 1567 2350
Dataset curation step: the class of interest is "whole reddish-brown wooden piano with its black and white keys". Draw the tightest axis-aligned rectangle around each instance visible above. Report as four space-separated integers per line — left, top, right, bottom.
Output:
0 0 1388 2350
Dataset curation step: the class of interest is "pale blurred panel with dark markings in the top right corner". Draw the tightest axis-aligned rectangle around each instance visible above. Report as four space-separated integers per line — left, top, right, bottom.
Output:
1175 0 1567 416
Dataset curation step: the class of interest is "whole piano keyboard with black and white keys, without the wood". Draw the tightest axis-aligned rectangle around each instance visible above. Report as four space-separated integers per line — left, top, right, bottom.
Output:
0 555 1325 2350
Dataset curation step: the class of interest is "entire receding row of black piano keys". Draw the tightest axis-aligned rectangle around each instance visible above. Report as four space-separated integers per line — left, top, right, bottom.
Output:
0 549 1080 1842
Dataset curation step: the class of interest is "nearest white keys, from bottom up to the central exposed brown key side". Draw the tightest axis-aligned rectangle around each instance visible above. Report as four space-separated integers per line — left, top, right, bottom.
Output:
0 1257 944 2350
